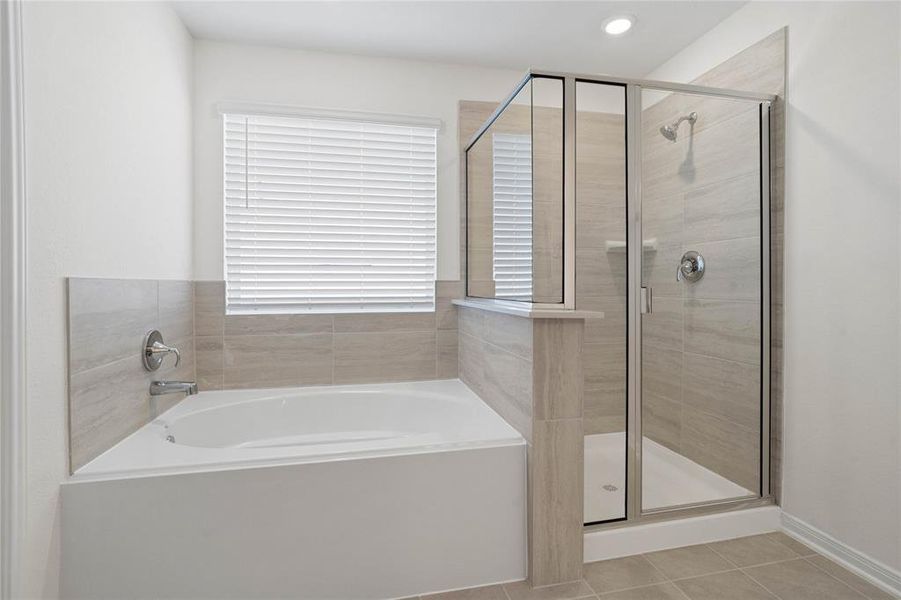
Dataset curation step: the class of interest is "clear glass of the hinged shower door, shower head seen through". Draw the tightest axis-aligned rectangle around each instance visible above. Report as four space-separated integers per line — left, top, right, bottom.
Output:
641 91 762 510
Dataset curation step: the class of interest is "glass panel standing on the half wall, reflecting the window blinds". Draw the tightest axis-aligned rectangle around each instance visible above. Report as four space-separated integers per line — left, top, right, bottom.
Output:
466 78 563 303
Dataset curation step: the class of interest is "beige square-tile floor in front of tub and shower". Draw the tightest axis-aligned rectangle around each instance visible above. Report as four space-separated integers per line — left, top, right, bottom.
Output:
420 533 893 600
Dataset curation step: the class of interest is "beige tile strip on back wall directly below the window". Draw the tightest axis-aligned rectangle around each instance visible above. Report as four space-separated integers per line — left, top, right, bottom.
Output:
194 281 463 390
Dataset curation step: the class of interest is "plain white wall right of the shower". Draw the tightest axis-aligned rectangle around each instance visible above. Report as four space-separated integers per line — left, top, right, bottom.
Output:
649 2 901 568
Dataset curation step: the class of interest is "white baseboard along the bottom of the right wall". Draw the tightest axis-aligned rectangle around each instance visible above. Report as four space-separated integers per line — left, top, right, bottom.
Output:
782 512 901 596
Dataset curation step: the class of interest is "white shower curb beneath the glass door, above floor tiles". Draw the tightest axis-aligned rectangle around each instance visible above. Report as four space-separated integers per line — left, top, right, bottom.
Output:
585 506 782 562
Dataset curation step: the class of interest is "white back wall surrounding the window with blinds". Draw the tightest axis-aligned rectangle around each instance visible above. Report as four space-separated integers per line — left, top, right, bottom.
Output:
194 41 523 279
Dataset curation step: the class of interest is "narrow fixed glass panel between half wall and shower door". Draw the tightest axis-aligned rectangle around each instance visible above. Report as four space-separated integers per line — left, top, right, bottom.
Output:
576 82 627 523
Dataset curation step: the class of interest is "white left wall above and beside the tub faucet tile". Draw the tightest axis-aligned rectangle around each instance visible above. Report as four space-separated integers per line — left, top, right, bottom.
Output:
22 2 192 597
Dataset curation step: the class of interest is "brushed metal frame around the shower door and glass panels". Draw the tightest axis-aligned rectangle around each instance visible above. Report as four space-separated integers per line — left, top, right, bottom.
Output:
528 69 776 531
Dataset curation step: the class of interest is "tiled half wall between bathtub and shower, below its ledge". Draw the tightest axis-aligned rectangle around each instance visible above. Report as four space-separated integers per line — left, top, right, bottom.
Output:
458 307 584 585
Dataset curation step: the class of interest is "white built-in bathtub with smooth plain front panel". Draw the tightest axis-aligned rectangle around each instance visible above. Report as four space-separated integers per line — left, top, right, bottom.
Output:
61 380 526 598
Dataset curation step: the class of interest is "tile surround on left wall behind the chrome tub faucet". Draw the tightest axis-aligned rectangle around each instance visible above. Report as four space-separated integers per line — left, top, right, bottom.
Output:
68 278 195 472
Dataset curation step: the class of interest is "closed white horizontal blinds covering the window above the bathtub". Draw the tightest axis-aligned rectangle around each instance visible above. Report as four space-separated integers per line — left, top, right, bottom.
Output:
224 114 437 314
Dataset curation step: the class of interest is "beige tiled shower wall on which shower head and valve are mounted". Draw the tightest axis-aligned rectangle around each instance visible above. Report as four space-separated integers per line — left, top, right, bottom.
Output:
642 31 785 493
